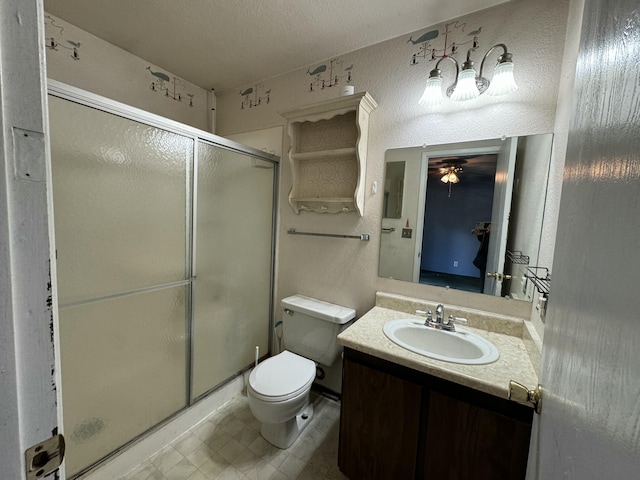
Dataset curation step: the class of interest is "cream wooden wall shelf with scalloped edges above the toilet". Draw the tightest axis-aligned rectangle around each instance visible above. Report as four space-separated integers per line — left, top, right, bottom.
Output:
280 93 378 216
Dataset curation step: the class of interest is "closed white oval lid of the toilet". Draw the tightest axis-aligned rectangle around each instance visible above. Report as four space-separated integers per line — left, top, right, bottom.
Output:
249 350 316 400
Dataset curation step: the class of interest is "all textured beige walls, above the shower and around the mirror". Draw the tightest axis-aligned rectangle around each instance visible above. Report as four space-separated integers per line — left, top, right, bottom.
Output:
45 0 579 330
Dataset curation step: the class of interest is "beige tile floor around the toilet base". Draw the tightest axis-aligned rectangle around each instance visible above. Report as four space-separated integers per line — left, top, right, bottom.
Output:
120 392 347 480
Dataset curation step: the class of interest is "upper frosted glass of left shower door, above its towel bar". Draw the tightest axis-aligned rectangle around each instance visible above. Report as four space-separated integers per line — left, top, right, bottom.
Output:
49 97 193 305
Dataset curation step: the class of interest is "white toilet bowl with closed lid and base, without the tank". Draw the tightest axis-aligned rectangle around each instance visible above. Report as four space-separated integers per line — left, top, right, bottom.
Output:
247 350 316 449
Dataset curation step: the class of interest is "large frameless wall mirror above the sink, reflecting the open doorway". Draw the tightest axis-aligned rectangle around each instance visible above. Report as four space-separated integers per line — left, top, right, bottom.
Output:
378 134 553 301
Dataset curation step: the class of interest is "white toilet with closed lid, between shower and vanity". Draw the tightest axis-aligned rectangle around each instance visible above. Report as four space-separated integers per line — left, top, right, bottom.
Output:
247 295 356 449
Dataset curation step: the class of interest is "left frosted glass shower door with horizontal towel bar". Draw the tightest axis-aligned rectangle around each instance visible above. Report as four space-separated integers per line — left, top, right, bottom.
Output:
49 96 194 476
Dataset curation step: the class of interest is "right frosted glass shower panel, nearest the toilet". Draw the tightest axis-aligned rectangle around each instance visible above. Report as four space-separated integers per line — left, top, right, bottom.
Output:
193 144 275 398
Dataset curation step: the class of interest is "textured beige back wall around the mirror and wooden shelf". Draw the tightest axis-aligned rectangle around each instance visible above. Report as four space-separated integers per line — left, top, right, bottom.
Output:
217 0 575 317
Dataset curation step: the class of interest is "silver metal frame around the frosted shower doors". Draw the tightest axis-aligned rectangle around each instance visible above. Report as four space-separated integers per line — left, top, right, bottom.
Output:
46 79 280 475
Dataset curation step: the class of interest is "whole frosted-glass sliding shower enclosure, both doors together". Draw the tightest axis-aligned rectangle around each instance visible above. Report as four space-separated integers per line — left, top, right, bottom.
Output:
49 82 278 477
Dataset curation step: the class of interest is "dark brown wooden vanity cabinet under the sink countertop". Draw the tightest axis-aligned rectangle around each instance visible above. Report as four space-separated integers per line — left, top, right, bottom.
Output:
338 348 533 480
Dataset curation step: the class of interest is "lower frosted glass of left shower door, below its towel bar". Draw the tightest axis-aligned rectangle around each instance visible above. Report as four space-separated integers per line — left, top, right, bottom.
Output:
60 286 187 475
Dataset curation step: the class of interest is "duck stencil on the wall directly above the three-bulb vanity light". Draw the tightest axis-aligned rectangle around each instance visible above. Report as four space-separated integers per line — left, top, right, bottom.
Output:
407 21 482 66
